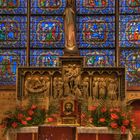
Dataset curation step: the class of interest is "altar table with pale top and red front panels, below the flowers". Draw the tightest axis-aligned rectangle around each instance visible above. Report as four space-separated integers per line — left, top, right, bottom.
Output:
6 125 132 140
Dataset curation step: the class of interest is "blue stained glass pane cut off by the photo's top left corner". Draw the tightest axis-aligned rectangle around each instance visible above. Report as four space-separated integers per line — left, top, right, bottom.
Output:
0 0 27 14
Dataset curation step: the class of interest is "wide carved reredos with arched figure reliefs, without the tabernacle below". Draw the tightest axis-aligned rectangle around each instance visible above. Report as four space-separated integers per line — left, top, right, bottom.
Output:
17 56 125 107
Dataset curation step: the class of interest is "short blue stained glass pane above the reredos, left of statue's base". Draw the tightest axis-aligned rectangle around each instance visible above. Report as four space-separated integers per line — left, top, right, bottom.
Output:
30 50 63 67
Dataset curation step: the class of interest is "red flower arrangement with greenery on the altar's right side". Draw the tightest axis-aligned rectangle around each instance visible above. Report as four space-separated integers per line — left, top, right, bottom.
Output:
81 99 136 134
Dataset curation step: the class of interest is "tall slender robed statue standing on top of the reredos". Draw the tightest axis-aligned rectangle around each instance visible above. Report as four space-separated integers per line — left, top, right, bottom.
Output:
63 0 78 53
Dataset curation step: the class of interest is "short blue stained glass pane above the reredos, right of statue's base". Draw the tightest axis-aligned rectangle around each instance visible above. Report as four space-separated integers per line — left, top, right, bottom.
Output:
80 49 115 67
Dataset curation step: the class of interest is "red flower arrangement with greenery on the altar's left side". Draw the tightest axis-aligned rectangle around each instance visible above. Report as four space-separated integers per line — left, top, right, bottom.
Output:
0 104 46 134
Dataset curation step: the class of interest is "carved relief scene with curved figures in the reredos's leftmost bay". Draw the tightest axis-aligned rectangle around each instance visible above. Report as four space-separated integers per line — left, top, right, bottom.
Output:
24 76 50 97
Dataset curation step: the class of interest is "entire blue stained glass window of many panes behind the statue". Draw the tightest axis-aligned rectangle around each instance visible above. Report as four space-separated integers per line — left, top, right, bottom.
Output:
0 0 140 87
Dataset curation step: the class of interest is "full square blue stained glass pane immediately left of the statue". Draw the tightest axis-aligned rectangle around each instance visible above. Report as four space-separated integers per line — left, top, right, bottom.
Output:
31 17 64 48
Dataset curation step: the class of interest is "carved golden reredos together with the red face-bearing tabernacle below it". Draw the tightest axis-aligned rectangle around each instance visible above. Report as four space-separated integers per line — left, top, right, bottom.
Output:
17 59 125 124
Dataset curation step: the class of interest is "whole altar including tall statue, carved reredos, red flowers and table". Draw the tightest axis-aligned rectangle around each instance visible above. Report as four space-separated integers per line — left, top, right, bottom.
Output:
0 0 133 140
